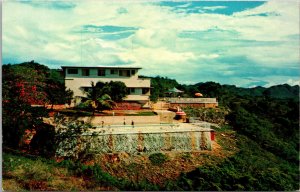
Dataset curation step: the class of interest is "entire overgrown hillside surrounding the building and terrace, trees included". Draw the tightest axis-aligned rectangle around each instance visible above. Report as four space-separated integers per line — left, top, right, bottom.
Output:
2 62 299 191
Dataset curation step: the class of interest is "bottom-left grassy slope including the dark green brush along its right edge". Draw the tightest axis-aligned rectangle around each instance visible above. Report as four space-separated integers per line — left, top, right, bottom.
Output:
2 152 159 191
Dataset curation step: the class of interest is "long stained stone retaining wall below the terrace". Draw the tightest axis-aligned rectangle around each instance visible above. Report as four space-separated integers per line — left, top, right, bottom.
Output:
59 131 211 156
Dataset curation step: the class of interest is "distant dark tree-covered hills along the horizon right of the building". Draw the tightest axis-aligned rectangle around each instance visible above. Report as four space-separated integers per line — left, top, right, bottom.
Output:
148 76 299 104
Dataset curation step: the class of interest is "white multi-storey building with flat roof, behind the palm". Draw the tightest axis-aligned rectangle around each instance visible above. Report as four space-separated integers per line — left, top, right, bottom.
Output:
62 66 150 104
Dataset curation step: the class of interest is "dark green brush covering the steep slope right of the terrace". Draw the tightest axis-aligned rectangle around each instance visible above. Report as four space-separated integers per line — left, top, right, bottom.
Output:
162 84 299 191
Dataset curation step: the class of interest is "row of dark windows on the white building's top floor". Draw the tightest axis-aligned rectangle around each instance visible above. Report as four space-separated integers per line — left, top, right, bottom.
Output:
68 69 136 77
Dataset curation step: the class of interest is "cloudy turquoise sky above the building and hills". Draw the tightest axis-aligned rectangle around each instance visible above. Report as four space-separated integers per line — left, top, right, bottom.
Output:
2 0 300 87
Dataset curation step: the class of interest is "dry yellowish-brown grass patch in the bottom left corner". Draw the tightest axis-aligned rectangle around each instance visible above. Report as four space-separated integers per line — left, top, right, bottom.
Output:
2 152 112 191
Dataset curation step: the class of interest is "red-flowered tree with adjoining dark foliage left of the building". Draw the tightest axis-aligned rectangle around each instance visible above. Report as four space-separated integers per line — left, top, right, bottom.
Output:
2 61 72 148
